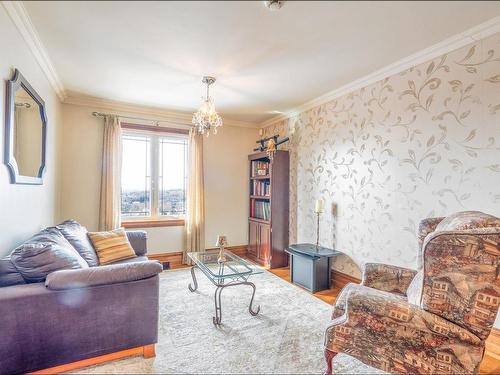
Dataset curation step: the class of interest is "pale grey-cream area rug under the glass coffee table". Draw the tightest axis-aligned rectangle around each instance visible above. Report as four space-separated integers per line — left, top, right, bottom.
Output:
70 269 381 374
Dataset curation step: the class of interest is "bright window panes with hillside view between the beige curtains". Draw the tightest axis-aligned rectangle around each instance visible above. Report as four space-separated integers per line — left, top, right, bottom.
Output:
121 130 188 226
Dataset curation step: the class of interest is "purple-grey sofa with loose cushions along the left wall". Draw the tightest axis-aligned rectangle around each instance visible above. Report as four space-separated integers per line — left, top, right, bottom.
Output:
0 221 162 374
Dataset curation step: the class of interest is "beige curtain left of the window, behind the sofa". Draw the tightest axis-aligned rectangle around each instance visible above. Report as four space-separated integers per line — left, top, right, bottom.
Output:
99 115 122 230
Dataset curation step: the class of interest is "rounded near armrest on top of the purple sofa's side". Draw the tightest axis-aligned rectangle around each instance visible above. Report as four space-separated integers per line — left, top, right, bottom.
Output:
45 261 163 290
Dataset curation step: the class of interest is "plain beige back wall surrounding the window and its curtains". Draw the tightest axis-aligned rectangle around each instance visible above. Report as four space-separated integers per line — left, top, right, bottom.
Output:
60 104 257 253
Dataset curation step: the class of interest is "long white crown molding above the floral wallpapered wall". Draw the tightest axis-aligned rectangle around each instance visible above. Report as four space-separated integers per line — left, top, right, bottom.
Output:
260 17 500 128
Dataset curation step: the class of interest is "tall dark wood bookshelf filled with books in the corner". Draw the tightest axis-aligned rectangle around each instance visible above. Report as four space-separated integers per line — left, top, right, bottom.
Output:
247 150 290 268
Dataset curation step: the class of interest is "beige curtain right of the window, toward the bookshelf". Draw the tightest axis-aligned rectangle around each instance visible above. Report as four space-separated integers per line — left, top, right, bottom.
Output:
184 128 205 264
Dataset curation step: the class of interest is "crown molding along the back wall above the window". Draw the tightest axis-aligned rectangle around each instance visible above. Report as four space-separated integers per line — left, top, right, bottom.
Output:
63 92 259 129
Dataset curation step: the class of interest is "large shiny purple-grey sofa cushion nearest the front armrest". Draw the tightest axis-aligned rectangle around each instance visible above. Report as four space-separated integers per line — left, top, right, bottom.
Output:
10 228 88 283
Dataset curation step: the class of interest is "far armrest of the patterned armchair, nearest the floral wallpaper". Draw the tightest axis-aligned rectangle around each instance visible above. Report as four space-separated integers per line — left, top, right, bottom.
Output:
361 263 417 295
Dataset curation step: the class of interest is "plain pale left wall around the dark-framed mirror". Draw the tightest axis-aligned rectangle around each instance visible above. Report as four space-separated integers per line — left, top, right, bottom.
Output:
0 6 61 257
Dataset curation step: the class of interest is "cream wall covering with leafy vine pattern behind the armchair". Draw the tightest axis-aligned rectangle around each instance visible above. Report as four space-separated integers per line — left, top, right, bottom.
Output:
265 34 500 276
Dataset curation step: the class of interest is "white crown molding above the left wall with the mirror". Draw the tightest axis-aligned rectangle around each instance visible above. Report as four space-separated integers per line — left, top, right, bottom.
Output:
2 1 66 101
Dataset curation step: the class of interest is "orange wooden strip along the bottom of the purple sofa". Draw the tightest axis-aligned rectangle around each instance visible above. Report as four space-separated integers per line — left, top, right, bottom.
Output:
29 344 155 375
